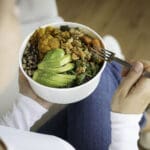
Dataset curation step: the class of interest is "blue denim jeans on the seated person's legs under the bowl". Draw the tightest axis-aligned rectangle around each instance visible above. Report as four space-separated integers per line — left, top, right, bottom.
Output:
38 63 121 150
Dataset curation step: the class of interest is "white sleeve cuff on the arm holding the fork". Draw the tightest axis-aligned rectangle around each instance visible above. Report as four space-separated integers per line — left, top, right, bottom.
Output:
109 112 142 150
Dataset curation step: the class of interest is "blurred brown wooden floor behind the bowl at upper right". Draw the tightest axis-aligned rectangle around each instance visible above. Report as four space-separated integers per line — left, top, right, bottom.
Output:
57 0 150 60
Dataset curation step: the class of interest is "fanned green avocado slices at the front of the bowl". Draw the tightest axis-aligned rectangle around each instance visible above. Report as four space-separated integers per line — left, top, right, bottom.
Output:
33 49 76 88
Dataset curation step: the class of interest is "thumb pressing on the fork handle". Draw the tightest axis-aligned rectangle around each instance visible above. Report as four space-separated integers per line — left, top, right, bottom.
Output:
119 62 144 96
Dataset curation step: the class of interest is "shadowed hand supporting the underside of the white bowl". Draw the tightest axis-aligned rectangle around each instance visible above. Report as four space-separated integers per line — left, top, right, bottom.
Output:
19 71 52 109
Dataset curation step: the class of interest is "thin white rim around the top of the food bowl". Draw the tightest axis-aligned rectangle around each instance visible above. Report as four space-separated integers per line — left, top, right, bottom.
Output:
19 21 106 91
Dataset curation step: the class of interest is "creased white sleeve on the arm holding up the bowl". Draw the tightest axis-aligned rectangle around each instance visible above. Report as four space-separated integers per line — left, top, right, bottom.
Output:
0 94 47 130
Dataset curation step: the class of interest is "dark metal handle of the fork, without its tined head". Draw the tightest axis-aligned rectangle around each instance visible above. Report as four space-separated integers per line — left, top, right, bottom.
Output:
113 57 150 78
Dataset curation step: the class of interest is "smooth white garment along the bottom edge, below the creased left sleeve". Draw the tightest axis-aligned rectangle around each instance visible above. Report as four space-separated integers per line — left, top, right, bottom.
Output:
0 125 75 150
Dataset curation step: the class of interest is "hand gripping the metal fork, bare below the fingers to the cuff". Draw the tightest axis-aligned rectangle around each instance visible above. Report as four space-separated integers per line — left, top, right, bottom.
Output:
111 61 150 114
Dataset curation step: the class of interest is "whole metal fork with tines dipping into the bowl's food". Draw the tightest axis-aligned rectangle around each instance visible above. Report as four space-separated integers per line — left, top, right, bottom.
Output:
91 48 150 78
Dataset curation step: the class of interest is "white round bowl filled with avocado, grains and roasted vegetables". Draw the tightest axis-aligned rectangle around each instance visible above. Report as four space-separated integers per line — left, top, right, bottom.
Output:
19 22 106 104
